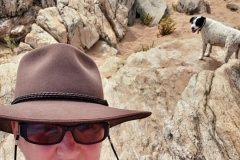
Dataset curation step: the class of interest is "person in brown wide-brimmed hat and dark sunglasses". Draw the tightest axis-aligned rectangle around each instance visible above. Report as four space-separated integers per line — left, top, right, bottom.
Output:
0 43 151 160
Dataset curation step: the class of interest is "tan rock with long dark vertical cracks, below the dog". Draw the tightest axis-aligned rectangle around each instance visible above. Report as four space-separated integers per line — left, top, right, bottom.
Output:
163 60 240 160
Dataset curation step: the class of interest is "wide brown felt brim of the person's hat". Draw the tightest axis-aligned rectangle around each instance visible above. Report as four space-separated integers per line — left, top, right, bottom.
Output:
0 100 151 133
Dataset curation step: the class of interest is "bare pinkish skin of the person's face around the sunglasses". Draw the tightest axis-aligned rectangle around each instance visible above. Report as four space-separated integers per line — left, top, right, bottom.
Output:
12 121 102 160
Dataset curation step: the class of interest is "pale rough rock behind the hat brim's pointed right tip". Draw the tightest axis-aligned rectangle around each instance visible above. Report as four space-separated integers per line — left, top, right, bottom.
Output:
101 48 197 160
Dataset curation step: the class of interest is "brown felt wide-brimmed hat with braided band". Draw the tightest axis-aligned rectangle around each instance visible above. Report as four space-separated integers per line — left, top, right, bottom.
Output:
0 43 151 133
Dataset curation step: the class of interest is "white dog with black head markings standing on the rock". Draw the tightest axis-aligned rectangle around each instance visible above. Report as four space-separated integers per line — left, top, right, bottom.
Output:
190 16 240 63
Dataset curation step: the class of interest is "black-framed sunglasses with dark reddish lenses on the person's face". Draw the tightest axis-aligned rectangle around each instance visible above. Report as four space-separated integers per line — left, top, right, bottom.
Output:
19 122 109 145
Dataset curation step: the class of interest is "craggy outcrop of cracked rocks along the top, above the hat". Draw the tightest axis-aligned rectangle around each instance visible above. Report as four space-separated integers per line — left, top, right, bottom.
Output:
0 0 167 50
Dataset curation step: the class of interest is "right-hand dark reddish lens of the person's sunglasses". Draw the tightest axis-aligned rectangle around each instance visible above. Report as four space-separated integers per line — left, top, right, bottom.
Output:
73 124 107 144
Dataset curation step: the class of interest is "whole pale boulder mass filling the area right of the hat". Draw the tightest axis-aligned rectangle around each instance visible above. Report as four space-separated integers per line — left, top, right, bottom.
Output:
102 50 240 160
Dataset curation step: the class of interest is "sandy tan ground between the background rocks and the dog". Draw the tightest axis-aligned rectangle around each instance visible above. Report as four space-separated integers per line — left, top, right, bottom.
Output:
89 0 240 63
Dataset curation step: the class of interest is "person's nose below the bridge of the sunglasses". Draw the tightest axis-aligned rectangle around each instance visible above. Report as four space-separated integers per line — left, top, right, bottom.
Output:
57 131 80 157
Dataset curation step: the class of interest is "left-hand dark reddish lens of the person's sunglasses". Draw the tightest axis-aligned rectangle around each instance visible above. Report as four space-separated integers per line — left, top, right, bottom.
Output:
27 124 62 144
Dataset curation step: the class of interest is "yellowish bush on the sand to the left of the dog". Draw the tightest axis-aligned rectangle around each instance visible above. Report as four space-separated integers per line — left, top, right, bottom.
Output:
157 15 176 36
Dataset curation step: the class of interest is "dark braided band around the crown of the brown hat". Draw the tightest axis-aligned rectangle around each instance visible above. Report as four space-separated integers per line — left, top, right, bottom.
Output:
11 92 108 106
